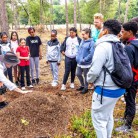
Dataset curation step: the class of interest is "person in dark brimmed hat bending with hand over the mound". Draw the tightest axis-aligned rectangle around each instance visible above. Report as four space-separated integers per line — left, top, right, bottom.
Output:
0 52 31 109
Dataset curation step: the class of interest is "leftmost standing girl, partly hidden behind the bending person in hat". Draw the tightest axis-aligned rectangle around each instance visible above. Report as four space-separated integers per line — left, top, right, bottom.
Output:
0 32 13 82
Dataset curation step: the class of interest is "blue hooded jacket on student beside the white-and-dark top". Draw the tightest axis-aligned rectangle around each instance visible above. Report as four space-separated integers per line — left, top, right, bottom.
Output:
76 39 94 65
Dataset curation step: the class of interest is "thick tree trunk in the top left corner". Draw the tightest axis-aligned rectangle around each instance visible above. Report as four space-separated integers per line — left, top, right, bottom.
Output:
0 0 9 34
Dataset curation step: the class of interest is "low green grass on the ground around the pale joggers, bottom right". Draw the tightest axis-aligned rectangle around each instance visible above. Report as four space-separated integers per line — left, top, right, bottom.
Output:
56 103 138 138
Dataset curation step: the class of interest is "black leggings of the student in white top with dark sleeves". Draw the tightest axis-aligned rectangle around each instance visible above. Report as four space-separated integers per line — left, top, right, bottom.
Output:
63 57 77 84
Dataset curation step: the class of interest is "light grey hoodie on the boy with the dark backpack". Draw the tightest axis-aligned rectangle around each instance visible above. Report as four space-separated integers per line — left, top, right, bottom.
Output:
87 34 120 90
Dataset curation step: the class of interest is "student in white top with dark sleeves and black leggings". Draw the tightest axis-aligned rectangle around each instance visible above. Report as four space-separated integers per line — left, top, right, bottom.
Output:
60 27 81 91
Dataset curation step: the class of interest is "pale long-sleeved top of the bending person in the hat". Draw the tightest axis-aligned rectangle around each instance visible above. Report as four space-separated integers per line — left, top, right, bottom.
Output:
0 62 17 91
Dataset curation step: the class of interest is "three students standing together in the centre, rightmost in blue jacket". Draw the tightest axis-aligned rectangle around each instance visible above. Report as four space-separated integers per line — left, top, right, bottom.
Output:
46 27 94 94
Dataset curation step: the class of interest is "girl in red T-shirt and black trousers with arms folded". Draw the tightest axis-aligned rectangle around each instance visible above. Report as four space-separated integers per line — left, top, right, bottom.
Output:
16 38 33 90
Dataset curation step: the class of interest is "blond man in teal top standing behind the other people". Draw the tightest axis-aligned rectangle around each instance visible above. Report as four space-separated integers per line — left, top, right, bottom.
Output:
91 13 104 42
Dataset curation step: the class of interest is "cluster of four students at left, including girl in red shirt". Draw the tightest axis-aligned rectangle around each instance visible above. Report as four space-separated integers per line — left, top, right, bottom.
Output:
0 27 42 90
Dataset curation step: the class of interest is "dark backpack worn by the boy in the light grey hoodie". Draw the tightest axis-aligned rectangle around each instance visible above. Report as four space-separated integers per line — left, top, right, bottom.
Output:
103 42 133 89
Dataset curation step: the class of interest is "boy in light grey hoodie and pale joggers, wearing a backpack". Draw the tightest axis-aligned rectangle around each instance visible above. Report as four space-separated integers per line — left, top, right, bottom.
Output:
87 20 125 138
